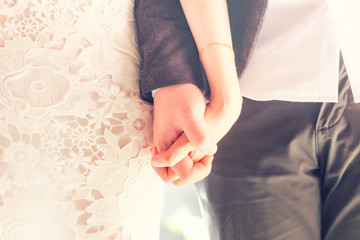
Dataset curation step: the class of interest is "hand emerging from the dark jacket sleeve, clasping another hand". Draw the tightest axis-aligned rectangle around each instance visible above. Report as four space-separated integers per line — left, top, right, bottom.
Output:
153 83 216 182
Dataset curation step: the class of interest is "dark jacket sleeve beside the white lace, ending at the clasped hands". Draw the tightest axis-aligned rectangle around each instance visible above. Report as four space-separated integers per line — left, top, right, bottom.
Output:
135 0 204 101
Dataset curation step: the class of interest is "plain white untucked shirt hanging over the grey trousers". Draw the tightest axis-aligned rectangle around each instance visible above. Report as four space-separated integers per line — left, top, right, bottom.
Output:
240 0 360 102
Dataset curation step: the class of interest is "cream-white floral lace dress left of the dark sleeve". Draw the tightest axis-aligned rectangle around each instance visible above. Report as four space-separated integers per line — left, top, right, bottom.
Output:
0 0 162 240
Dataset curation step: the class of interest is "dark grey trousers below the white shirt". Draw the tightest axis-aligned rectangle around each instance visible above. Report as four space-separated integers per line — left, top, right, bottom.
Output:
197 59 360 240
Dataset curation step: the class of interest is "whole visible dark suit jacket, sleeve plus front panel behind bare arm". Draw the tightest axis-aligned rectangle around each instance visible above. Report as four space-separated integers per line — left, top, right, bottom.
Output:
135 0 267 101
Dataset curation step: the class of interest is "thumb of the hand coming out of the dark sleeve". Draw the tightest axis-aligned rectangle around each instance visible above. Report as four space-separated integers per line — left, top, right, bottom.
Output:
184 116 217 155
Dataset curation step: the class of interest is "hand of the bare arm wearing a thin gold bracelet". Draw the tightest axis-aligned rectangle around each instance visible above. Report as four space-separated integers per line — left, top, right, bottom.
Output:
152 94 242 186
